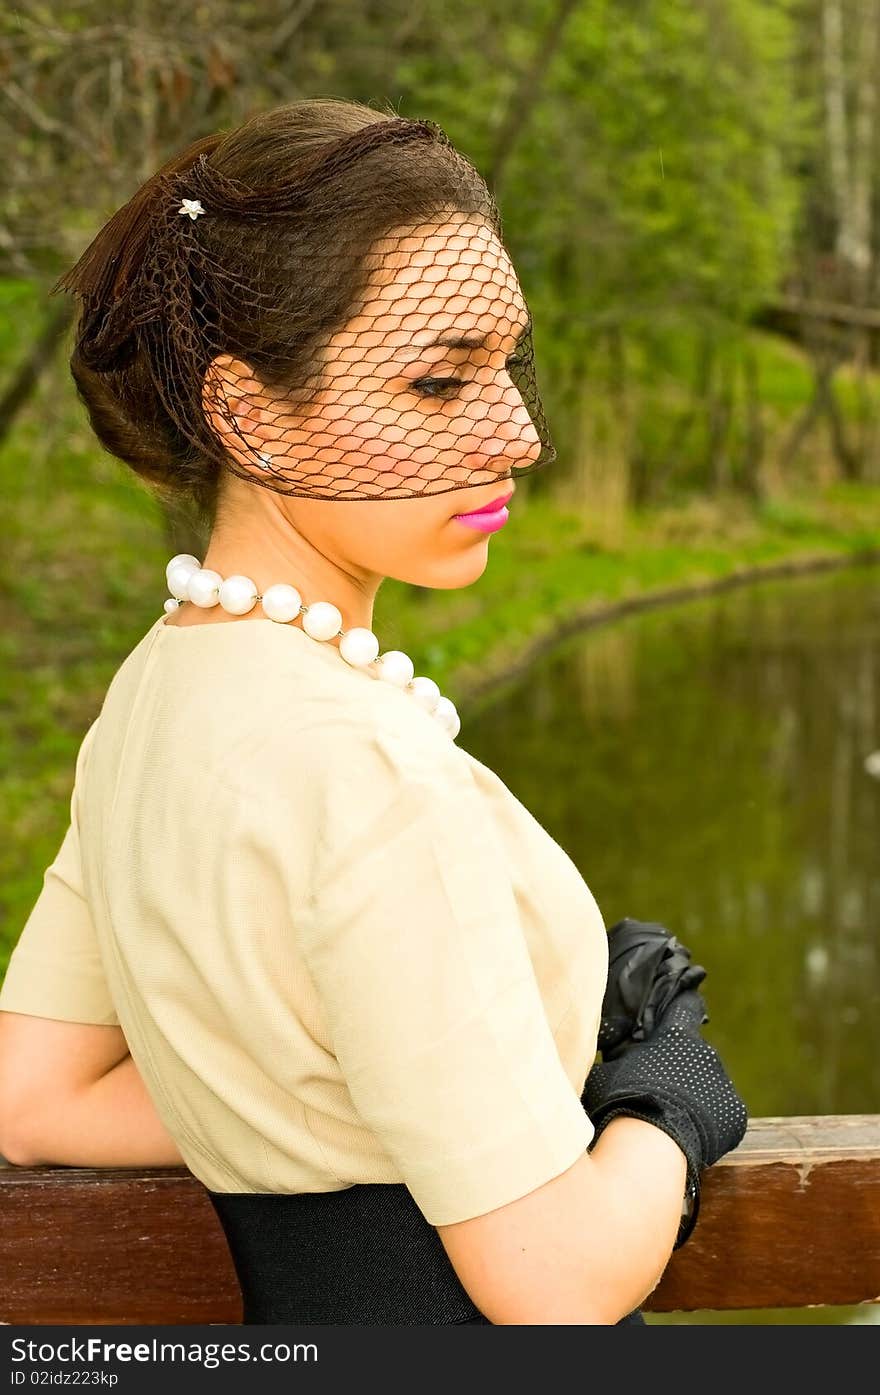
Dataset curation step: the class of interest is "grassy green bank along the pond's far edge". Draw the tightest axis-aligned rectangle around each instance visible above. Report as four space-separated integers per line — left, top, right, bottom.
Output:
377 484 880 721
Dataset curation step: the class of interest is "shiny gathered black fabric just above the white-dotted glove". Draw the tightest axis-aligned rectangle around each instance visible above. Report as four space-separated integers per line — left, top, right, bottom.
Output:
597 918 708 1060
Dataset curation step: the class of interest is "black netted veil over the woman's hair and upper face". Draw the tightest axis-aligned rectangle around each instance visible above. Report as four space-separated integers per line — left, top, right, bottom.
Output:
56 119 555 499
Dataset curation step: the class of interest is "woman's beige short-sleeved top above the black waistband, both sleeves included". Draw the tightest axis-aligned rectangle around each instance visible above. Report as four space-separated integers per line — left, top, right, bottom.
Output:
0 617 608 1225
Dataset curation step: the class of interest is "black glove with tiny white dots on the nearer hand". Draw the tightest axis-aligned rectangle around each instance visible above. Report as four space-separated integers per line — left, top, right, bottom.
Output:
580 989 749 1250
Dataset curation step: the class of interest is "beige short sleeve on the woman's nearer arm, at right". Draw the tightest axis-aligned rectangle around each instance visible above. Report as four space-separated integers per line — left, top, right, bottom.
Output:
298 724 593 1225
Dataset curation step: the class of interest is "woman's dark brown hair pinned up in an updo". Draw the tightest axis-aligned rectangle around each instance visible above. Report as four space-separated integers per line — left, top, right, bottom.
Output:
53 98 499 525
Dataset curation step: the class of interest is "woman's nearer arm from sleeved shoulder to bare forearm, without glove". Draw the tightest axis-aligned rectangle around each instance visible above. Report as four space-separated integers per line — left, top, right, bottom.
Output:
288 734 686 1324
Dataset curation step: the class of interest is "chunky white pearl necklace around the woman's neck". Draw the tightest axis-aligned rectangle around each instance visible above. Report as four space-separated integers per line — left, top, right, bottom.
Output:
165 552 462 741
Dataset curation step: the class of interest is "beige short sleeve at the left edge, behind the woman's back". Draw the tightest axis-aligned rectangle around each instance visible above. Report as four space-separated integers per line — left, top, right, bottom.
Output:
0 718 119 1027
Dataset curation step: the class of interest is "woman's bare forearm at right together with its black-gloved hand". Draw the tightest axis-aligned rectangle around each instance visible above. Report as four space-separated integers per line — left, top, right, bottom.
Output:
438 922 748 1324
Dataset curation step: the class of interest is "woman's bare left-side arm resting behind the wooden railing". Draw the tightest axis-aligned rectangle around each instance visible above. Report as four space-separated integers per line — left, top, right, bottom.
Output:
0 1011 183 1168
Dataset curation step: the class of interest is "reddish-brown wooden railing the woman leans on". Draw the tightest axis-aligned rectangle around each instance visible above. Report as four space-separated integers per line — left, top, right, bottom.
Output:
0 1115 880 1324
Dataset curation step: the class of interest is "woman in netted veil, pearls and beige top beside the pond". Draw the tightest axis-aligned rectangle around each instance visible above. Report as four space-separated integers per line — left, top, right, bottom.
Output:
0 100 745 1324
